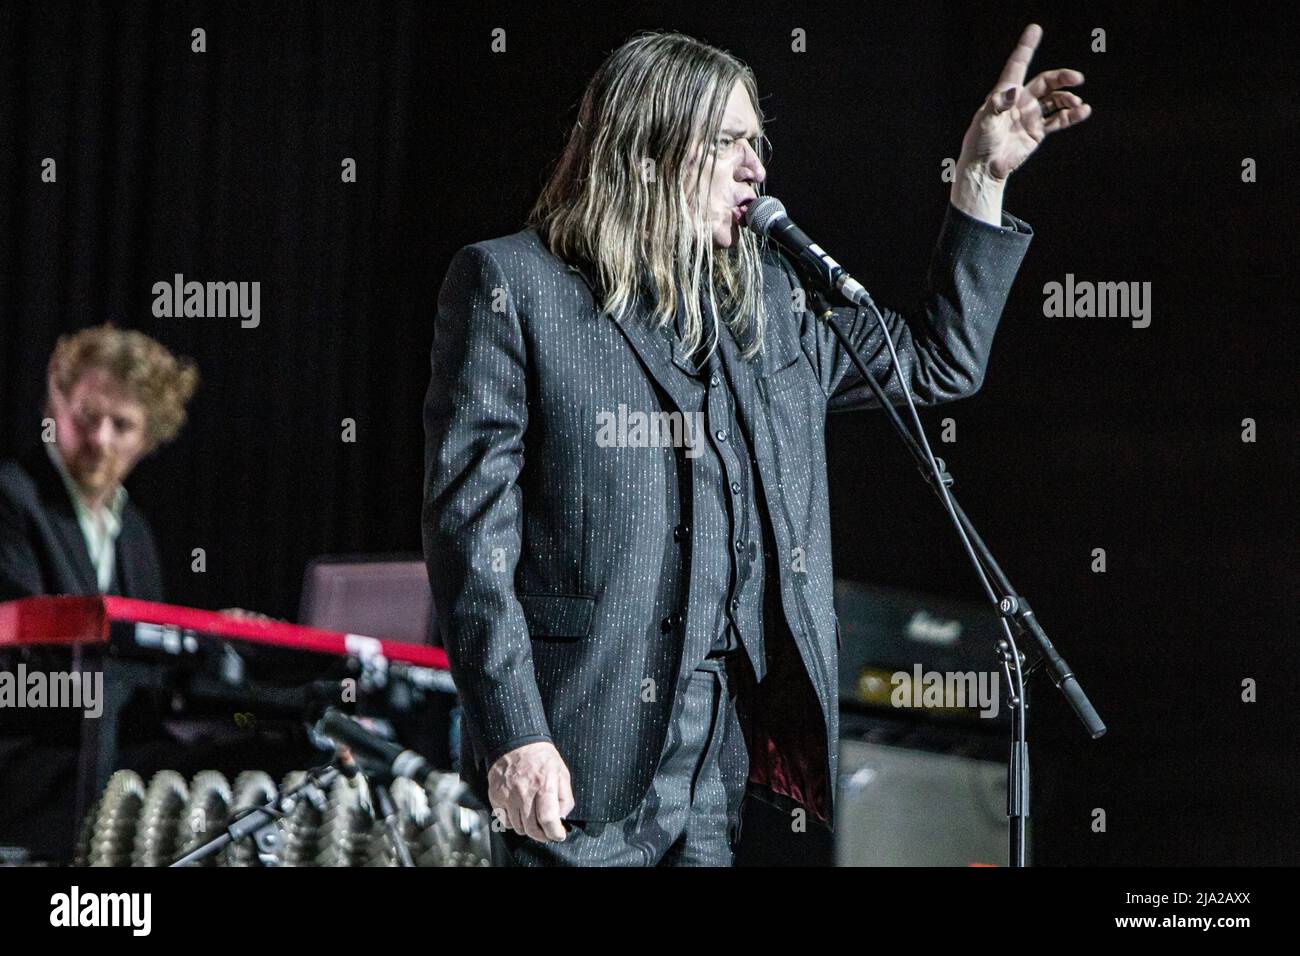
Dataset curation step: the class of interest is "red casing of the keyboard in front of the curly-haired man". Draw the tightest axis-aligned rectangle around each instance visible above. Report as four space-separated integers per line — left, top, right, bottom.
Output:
0 596 447 670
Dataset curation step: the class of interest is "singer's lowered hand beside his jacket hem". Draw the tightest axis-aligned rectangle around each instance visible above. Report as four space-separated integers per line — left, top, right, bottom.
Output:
488 740 573 843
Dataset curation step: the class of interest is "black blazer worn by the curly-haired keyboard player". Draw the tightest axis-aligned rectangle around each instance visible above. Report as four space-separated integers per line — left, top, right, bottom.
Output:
0 445 163 601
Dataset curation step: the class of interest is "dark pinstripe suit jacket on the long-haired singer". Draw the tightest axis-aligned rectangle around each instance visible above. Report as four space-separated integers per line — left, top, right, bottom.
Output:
423 204 1032 826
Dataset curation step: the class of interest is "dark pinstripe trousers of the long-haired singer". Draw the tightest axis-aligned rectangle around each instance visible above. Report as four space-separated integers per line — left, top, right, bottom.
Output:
491 650 749 866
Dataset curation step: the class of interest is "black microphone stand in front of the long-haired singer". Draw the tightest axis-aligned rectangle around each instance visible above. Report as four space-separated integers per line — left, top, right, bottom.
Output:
805 282 1106 866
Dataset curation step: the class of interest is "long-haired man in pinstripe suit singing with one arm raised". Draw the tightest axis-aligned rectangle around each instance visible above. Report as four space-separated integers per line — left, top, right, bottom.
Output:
424 25 1089 866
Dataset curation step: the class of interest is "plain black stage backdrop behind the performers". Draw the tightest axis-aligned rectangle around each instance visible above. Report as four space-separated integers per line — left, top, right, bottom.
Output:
0 3 1300 864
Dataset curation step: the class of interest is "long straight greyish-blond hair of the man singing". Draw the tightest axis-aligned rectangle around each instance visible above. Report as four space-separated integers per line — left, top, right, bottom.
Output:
528 31 766 358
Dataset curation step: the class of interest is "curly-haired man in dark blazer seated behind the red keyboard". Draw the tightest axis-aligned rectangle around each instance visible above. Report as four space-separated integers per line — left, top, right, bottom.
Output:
0 325 199 858
